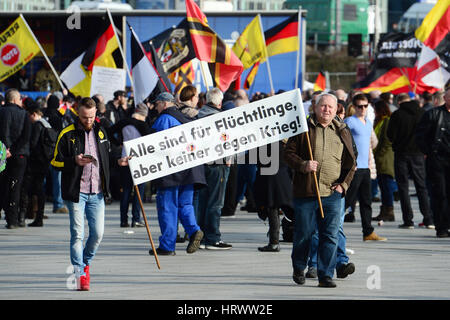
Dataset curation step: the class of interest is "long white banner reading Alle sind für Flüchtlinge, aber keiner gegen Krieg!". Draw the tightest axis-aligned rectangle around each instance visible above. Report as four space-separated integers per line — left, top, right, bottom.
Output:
124 89 308 185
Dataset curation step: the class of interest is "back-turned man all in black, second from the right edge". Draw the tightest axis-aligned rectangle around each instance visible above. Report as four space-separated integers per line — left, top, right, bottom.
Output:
387 98 434 229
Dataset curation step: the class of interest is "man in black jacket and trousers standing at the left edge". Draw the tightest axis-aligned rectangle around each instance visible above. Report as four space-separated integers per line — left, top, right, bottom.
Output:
0 89 31 229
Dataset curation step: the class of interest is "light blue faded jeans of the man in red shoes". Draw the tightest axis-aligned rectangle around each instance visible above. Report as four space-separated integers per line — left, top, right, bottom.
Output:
66 193 105 275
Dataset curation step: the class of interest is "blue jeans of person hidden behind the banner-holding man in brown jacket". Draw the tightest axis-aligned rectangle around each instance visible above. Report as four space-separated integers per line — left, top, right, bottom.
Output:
308 198 349 269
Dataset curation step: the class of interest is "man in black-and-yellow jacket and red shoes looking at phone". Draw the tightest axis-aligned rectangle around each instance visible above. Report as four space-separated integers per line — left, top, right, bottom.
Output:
51 98 110 291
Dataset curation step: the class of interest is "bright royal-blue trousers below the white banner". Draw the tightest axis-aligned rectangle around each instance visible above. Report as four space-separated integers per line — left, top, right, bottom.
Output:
156 184 200 251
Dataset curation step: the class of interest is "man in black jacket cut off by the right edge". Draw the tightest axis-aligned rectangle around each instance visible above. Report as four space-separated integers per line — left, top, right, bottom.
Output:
416 88 450 238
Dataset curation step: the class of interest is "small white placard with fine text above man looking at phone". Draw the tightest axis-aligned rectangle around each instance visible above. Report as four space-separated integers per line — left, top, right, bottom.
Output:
91 66 126 101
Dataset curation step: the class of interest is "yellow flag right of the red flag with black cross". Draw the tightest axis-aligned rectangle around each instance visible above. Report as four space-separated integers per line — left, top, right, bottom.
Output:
232 14 267 69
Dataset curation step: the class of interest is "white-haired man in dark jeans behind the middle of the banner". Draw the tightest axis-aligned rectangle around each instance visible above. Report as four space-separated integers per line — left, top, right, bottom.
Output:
197 88 232 250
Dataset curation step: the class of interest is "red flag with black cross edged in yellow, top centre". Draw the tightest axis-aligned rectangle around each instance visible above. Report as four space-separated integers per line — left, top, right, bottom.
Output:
186 0 244 91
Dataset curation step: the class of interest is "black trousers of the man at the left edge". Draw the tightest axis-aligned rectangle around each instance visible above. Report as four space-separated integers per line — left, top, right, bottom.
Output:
2 156 27 226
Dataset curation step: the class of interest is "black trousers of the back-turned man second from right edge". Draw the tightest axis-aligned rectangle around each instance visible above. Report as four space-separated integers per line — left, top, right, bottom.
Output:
394 153 433 225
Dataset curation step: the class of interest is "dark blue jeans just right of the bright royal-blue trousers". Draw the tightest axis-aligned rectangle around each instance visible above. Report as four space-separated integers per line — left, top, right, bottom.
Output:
197 165 230 244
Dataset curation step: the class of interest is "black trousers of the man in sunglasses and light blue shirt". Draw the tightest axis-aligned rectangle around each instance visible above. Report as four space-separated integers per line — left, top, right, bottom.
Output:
345 169 374 236
